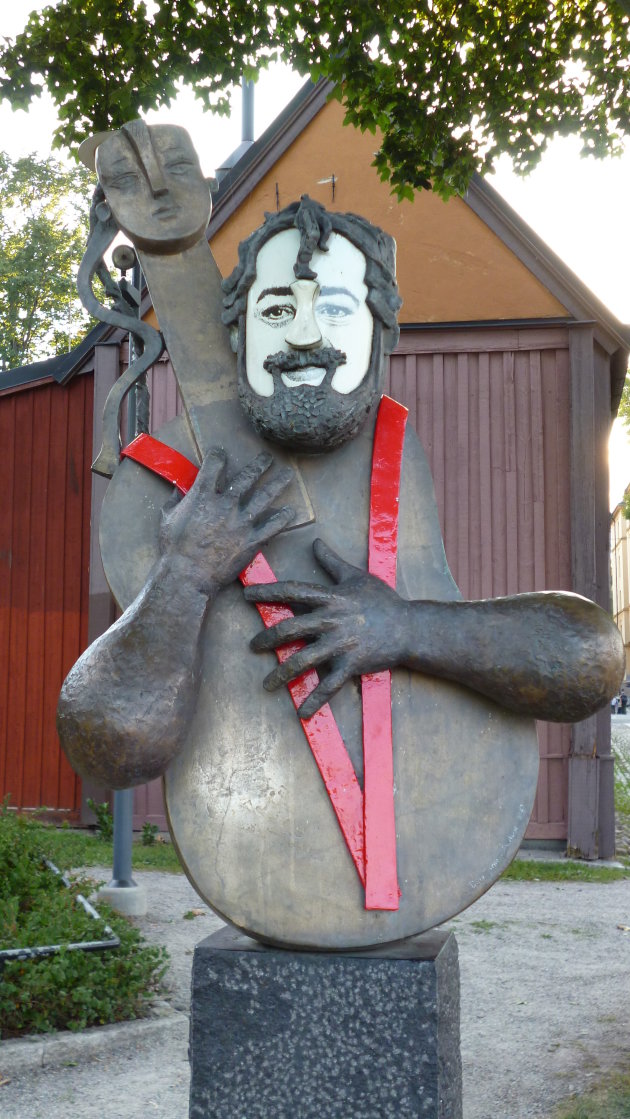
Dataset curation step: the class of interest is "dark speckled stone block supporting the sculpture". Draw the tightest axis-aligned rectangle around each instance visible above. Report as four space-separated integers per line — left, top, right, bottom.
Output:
190 929 462 1119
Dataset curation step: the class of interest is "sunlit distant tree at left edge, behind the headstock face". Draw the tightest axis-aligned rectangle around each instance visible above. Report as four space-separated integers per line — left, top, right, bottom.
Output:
0 152 91 370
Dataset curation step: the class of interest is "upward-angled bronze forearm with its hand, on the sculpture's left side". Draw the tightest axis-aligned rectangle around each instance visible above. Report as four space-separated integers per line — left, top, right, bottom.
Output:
57 452 292 789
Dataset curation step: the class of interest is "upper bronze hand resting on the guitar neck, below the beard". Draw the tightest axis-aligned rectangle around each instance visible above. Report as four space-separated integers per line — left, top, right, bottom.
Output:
160 450 294 590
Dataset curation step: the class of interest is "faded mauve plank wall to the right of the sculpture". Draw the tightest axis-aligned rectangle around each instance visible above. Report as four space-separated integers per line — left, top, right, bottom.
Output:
389 329 572 839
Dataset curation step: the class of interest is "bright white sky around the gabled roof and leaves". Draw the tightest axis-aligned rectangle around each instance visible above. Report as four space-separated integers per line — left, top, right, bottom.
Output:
0 0 630 508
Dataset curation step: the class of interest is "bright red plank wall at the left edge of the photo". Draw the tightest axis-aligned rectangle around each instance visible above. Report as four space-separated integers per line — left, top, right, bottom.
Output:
0 376 93 818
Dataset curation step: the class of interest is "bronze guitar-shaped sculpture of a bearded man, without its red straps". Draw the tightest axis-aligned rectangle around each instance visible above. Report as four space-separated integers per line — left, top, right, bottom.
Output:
58 122 623 948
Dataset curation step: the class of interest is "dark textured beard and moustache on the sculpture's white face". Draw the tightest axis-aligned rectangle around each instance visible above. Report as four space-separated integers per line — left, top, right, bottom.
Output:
238 322 383 452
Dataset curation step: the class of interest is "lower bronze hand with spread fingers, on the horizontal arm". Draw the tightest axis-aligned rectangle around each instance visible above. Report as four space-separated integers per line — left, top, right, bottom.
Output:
245 540 407 718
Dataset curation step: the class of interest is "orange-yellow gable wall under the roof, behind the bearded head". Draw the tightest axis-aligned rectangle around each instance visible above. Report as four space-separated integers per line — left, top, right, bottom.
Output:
210 95 567 322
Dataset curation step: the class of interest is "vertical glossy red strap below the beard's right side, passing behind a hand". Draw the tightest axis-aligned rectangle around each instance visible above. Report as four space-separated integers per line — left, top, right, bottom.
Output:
361 396 407 910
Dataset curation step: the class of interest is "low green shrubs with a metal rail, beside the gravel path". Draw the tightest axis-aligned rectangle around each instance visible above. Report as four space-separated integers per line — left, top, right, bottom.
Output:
0 810 168 1038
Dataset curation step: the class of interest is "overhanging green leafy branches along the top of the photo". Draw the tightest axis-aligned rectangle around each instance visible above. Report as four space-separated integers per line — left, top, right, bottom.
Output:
0 0 630 197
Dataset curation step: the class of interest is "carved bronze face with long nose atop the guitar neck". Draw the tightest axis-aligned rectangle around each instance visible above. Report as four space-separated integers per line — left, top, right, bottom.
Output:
96 121 211 253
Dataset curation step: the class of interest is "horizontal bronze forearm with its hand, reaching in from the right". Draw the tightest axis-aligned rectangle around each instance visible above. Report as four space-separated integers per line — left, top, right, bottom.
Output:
245 540 624 722
